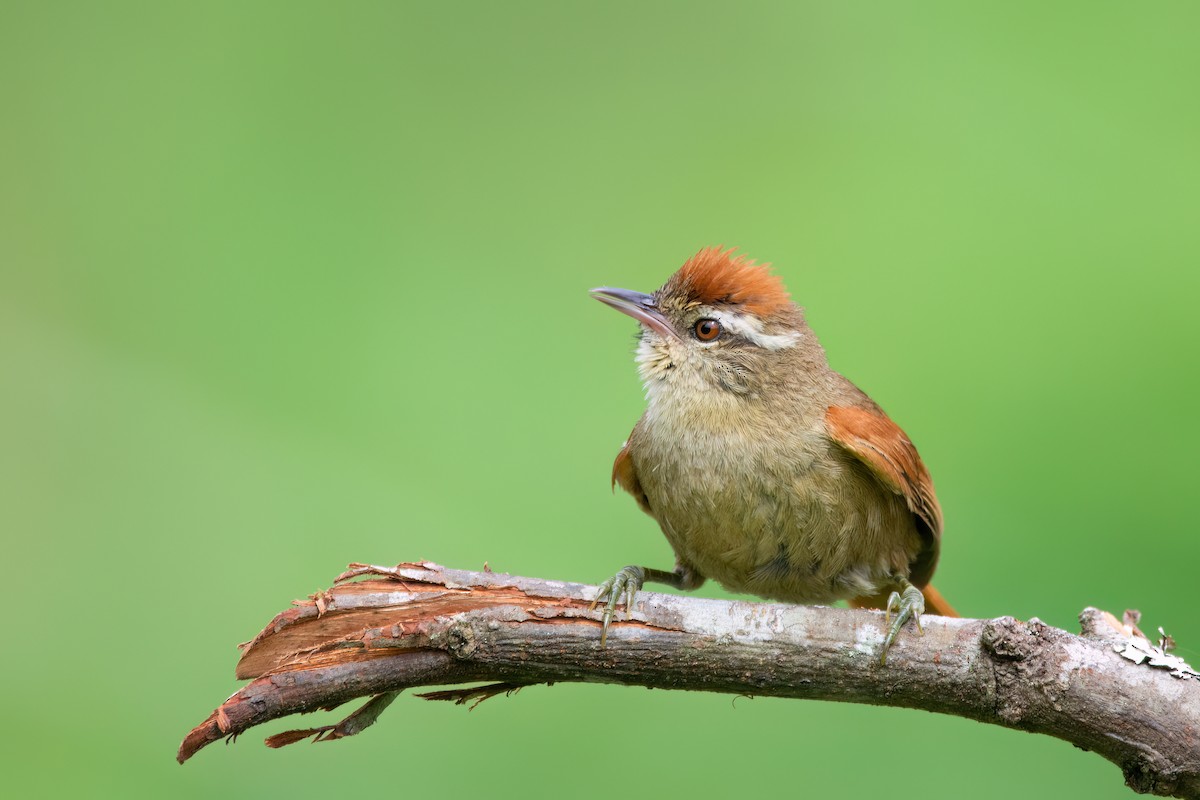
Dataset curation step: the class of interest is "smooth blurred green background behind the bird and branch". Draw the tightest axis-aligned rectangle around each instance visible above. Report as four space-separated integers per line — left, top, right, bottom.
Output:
0 0 1200 798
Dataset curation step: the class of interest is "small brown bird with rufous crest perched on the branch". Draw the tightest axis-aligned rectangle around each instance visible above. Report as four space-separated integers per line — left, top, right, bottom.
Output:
592 247 958 661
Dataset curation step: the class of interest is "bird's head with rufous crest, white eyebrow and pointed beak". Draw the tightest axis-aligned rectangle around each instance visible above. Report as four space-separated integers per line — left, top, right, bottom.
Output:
592 247 811 399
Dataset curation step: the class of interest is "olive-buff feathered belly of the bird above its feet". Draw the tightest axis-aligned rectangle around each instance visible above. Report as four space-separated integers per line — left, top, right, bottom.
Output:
640 441 920 603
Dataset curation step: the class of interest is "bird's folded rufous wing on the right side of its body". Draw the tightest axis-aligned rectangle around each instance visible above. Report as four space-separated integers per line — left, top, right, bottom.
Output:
826 405 942 587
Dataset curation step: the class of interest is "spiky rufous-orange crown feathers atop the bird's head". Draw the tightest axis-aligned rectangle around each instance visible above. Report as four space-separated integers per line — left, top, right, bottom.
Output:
664 247 791 318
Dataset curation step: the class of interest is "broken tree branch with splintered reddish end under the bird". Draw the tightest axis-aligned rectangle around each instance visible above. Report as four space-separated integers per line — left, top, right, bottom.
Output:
179 564 1200 798
